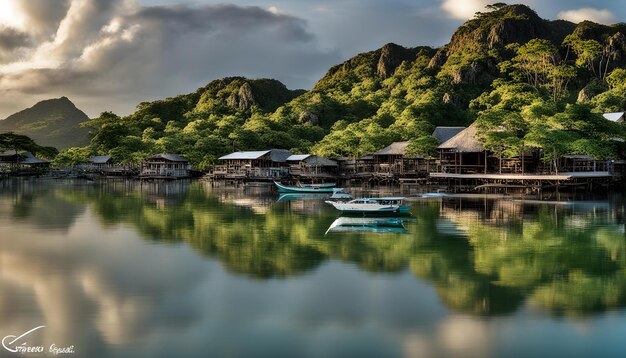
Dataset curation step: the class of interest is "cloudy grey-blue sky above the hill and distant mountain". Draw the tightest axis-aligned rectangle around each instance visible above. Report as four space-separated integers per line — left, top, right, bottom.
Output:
0 0 626 118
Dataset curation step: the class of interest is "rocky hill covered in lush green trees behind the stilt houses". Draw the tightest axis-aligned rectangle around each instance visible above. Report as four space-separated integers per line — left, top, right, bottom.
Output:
76 4 626 167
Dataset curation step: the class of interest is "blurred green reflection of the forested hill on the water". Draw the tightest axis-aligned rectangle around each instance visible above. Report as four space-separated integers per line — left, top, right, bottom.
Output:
3 183 626 315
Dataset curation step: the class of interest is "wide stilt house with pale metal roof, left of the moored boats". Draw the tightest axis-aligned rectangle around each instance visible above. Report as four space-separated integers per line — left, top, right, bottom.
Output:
213 149 293 180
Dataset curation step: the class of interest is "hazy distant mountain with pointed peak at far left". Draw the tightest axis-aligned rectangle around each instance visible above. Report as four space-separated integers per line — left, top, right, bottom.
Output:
0 97 89 149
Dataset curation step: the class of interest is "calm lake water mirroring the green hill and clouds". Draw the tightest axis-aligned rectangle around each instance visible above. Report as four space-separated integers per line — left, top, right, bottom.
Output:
0 180 626 357
